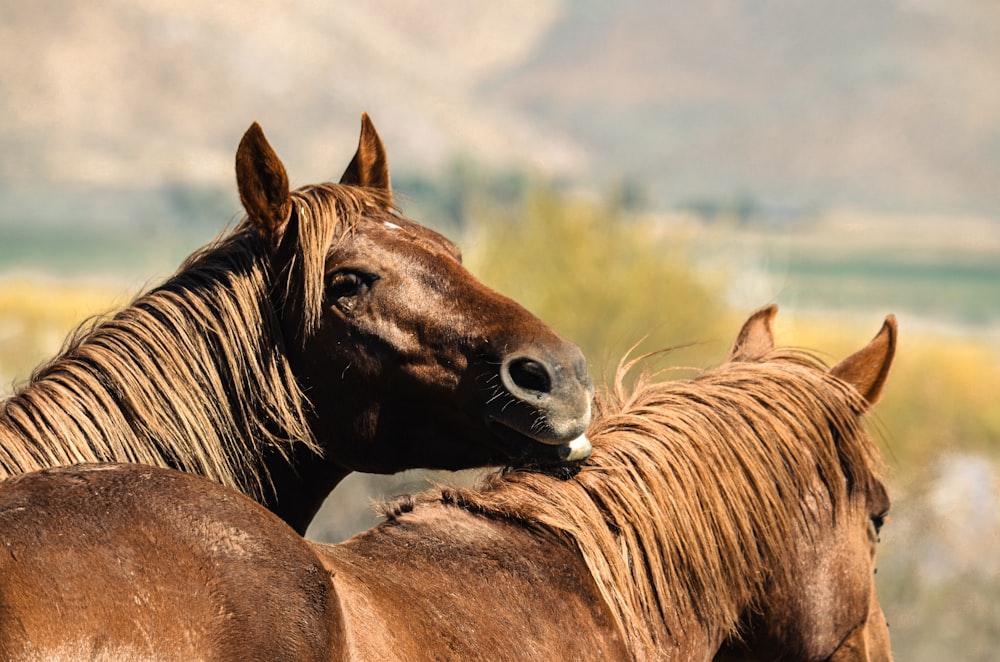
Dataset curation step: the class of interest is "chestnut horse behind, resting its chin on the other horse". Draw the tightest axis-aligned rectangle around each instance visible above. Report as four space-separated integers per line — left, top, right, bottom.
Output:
0 115 592 532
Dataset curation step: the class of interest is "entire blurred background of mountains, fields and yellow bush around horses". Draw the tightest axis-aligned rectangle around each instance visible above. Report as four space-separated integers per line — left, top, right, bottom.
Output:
0 0 1000 660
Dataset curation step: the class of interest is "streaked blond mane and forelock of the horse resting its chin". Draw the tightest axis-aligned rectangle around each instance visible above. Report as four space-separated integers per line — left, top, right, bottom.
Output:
0 184 385 498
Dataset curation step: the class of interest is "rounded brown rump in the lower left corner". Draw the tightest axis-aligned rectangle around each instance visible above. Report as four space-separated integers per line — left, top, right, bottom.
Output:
0 465 336 660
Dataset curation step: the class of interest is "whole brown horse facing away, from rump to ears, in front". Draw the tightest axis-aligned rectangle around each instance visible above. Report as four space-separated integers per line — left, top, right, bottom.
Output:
0 308 896 660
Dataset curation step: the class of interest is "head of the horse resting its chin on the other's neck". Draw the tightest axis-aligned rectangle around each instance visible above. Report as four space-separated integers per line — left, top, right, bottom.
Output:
236 115 593 512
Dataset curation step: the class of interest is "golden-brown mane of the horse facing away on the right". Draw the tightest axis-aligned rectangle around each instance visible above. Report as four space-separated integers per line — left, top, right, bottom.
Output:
421 350 881 657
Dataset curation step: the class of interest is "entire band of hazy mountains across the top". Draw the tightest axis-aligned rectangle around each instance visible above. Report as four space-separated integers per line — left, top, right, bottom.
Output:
0 0 1000 216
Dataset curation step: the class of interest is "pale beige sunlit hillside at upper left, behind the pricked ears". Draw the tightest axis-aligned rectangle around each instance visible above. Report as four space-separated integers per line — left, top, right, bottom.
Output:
0 0 575 195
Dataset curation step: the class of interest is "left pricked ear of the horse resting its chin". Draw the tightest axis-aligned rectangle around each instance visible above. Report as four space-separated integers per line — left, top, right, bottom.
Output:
236 122 292 244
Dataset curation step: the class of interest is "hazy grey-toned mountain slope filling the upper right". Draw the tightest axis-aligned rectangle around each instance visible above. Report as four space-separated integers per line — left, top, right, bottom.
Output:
485 0 1000 213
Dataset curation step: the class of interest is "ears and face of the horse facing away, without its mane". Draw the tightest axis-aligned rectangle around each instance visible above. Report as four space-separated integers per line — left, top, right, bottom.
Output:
716 305 898 661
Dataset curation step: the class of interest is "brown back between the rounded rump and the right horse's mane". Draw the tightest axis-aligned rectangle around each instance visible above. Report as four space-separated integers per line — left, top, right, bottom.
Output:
311 504 629 661
